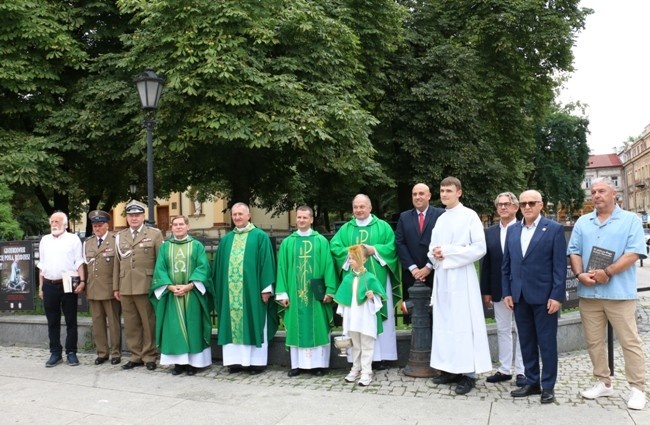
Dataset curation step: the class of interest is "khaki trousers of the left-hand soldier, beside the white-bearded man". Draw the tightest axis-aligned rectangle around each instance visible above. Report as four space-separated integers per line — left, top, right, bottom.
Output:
88 299 122 358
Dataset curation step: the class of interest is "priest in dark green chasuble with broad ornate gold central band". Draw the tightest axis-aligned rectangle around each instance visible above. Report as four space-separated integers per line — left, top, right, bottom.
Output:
212 202 278 374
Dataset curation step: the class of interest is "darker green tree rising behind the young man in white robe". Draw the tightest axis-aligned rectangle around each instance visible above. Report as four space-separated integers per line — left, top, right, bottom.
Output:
373 0 590 211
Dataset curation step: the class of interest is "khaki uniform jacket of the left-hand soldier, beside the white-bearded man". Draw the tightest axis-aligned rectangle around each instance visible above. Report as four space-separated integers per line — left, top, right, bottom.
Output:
83 232 116 300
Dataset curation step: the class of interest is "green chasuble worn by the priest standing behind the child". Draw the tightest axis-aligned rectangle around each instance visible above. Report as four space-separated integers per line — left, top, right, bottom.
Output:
330 214 402 317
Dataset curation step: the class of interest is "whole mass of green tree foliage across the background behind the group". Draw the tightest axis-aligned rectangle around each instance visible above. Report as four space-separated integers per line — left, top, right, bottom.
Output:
0 0 589 232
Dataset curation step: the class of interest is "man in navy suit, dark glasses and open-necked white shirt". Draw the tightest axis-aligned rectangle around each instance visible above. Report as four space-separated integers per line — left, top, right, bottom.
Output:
502 190 567 403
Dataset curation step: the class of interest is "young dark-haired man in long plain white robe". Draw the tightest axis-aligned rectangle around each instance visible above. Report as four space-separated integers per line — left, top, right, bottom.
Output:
429 177 492 394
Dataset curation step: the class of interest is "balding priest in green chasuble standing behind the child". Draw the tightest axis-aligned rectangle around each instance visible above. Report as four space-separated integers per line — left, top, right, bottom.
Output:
330 194 402 370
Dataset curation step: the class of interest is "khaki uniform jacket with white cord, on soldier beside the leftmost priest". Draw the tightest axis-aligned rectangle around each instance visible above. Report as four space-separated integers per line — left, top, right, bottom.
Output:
113 226 163 295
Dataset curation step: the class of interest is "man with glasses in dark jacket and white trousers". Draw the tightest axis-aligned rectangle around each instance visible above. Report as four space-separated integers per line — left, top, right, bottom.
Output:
481 192 526 387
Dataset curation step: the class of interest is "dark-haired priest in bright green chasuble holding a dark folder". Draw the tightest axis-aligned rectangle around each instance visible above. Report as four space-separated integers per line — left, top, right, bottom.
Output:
275 206 337 376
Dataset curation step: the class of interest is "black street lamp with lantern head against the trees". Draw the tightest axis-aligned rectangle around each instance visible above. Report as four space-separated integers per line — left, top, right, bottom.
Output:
135 68 165 227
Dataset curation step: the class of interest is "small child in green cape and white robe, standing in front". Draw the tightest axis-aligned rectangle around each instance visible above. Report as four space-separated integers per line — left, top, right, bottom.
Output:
334 245 386 386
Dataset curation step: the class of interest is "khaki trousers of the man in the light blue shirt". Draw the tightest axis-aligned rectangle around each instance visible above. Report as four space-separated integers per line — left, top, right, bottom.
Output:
579 298 645 391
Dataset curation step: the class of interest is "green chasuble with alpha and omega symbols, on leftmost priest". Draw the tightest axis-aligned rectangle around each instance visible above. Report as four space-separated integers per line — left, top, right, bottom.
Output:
149 236 212 355
